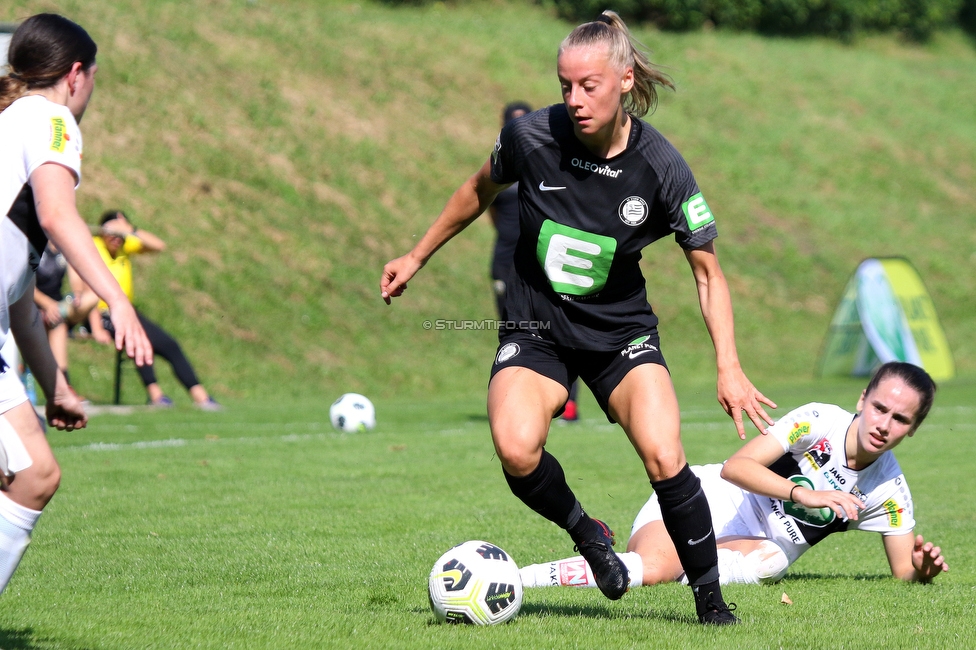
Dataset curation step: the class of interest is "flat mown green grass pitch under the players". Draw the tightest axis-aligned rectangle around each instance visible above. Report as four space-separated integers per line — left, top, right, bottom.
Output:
0 382 976 649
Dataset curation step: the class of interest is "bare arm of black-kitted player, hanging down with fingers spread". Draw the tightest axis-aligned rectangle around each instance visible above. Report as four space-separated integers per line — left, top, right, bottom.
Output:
685 242 776 440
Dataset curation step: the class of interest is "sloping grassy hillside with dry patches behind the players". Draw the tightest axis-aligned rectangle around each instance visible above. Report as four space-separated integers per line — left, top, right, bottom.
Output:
0 0 976 399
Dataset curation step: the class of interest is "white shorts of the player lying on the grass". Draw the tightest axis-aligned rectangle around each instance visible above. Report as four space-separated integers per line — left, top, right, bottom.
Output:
630 464 768 540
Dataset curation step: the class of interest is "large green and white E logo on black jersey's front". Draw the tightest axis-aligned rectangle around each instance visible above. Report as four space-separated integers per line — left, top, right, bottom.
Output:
536 219 617 296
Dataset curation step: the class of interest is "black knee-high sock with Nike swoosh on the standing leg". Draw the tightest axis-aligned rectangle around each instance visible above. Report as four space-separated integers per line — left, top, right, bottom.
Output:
651 465 722 604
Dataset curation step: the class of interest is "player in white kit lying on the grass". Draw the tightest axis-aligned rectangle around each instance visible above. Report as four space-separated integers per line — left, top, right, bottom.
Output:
521 362 949 587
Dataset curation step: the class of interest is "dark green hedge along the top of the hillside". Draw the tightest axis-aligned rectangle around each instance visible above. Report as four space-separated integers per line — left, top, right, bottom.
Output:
553 0 976 40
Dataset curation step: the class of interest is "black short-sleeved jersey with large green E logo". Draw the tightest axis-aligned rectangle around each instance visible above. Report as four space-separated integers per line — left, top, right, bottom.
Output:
491 104 717 350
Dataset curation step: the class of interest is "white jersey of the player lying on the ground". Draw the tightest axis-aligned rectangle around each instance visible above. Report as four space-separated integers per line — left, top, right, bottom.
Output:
748 403 915 563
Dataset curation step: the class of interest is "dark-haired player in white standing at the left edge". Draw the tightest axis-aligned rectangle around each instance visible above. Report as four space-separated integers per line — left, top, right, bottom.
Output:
0 14 152 591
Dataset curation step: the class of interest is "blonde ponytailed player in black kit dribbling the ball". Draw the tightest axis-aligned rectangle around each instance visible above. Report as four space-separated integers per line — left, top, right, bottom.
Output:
380 11 775 625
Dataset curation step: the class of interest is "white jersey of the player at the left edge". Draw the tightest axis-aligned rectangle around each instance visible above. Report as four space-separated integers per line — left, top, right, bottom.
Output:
0 95 82 345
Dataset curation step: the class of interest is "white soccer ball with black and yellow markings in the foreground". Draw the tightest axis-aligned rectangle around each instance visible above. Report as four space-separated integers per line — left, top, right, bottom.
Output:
427 541 522 625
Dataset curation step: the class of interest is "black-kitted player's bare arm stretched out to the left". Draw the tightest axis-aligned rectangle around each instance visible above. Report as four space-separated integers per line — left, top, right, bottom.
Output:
380 160 506 305
